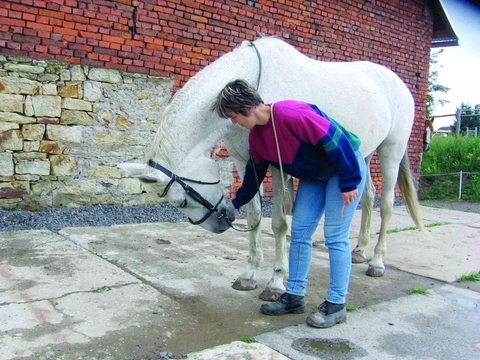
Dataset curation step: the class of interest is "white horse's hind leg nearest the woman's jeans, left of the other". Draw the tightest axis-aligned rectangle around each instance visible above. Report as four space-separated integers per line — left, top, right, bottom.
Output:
352 155 375 264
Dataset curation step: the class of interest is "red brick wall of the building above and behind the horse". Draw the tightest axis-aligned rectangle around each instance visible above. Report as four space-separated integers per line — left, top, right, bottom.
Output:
0 0 433 198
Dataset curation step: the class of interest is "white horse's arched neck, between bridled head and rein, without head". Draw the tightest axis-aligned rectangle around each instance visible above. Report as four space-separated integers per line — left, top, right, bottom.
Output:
147 44 259 168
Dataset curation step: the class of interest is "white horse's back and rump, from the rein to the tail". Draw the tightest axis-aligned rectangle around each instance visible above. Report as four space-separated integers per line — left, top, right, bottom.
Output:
253 38 414 156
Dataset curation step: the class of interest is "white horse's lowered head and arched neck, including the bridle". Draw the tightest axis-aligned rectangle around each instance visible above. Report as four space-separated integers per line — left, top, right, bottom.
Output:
119 43 266 233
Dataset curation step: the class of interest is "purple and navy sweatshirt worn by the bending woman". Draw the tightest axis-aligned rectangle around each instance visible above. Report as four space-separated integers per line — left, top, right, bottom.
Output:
232 100 361 209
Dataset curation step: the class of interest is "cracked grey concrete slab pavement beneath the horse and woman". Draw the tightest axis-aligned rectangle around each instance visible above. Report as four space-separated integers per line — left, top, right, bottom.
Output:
0 207 480 360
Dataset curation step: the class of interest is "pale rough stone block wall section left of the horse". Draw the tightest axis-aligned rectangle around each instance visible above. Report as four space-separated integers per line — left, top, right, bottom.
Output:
0 55 173 210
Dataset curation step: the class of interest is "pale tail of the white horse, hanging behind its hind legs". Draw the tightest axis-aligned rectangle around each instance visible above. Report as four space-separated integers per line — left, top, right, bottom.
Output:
397 152 429 236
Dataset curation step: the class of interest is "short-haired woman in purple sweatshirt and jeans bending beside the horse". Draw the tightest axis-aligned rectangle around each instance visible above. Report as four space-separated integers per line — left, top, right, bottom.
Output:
212 79 366 328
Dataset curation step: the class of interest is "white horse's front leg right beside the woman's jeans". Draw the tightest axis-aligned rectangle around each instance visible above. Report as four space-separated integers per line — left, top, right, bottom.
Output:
259 168 293 301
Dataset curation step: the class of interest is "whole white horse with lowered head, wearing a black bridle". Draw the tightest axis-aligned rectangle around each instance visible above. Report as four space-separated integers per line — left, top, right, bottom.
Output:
119 38 424 300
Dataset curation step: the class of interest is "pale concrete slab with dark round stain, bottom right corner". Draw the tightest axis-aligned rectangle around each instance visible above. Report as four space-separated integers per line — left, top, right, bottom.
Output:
255 285 480 360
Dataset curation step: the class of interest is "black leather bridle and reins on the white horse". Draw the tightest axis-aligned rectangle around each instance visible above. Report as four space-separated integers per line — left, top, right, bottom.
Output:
148 41 262 232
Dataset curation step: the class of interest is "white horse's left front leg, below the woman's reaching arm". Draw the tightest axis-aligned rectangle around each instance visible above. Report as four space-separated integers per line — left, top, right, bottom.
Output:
232 194 263 291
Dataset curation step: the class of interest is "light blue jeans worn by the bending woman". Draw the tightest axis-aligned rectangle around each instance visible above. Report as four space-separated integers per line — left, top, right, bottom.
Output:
287 151 366 304
